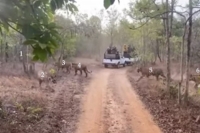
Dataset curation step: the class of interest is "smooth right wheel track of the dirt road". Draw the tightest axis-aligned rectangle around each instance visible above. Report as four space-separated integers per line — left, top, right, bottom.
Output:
113 69 162 133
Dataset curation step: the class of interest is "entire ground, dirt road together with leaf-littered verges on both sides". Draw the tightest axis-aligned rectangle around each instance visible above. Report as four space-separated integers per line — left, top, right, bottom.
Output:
0 58 200 133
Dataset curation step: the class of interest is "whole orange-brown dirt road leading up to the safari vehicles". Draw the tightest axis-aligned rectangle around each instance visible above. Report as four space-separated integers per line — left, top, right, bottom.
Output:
77 68 161 133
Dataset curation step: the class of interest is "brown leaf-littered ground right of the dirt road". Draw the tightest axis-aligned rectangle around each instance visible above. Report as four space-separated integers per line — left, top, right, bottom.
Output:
128 67 200 133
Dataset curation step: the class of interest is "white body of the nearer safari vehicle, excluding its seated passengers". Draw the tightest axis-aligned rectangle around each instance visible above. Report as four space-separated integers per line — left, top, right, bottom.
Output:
103 53 126 68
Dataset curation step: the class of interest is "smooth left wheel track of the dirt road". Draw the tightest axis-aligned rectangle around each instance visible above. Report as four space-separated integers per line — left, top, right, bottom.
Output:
77 70 109 133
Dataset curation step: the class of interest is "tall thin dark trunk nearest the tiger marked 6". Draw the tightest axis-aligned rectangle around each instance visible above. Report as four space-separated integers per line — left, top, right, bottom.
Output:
184 0 192 104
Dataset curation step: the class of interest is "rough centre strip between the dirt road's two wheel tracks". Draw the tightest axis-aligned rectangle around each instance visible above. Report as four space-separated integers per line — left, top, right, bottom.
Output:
104 72 132 133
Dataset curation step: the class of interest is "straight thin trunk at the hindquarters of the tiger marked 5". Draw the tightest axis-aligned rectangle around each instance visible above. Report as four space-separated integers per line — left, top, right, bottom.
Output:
166 0 170 91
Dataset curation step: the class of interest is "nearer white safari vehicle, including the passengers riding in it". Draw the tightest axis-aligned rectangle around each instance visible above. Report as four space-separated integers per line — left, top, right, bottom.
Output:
103 47 126 68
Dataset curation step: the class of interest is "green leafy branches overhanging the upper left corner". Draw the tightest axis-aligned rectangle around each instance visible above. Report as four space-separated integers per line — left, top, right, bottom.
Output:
0 0 78 62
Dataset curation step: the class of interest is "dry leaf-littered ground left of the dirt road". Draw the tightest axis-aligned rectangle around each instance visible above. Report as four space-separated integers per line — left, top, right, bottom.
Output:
0 58 95 133
